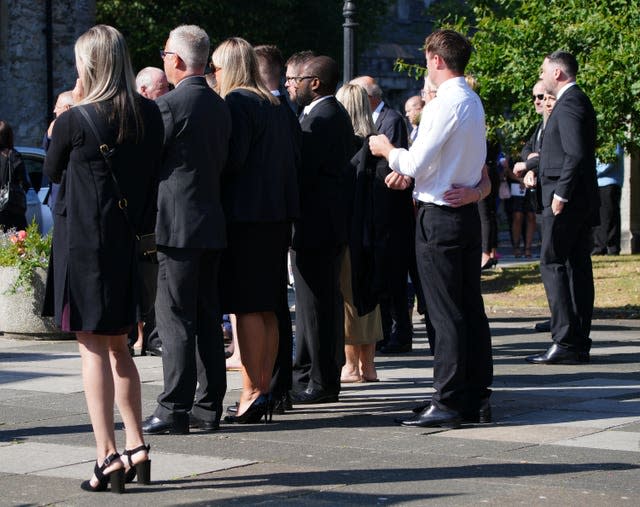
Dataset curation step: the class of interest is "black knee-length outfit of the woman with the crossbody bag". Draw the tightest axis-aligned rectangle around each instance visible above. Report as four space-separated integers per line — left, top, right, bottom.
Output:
43 97 163 334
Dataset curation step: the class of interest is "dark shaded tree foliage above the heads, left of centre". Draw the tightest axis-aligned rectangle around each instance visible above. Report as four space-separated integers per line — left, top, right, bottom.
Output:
97 0 391 75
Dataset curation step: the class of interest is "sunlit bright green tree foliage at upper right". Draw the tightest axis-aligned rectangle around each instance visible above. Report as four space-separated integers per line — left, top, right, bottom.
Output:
400 0 640 159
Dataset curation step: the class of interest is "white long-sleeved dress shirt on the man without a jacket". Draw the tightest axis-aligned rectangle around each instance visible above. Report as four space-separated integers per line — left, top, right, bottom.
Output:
389 77 487 206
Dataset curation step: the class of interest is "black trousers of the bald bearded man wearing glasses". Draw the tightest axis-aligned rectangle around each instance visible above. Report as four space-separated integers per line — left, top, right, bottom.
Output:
291 246 345 393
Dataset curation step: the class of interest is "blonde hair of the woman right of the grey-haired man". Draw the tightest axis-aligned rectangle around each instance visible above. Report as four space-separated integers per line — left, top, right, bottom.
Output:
211 37 279 104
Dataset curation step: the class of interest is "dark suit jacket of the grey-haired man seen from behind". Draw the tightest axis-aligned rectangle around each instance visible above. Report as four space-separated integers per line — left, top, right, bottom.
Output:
156 76 231 249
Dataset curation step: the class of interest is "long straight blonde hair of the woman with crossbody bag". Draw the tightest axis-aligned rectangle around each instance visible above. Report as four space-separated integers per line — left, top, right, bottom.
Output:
74 25 142 143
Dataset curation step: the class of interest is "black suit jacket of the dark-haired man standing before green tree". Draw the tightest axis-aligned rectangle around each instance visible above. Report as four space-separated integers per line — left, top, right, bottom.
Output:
539 85 600 225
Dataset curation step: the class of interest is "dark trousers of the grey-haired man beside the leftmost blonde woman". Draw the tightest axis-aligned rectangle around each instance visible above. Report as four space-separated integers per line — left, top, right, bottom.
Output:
155 245 227 421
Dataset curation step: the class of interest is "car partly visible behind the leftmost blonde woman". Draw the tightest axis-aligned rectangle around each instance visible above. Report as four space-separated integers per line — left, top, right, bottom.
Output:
15 146 53 234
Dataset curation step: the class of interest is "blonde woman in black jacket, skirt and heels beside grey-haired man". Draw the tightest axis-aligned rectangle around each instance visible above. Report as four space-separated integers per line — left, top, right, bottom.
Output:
211 37 301 424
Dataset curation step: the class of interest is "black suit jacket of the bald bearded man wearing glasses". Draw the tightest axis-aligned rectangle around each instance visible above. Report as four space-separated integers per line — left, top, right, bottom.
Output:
293 97 356 248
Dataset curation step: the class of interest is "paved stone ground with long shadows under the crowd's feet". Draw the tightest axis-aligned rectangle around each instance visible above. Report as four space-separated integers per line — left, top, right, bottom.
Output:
0 314 640 506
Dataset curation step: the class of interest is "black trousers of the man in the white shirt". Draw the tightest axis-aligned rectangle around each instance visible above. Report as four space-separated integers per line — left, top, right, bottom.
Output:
416 204 493 413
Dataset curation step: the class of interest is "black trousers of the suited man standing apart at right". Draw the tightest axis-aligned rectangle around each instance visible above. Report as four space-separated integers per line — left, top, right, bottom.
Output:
540 207 594 352
